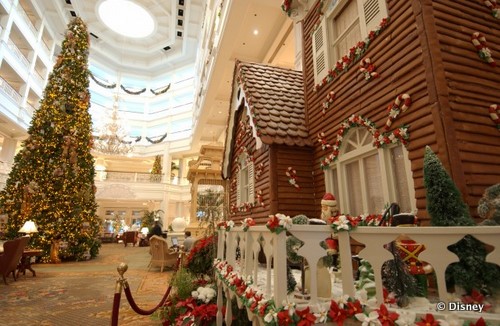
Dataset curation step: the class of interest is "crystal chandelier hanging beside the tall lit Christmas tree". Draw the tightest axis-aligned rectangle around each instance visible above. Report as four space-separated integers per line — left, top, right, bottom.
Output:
94 96 133 155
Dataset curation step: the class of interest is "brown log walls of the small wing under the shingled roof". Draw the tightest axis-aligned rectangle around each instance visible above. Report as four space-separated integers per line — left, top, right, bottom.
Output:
229 109 319 224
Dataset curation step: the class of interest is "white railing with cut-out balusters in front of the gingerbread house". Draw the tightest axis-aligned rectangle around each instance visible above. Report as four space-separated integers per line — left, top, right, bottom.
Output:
216 225 500 325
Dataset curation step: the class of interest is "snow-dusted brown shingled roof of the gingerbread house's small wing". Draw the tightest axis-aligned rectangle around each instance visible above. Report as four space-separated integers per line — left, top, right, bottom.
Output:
235 62 312 146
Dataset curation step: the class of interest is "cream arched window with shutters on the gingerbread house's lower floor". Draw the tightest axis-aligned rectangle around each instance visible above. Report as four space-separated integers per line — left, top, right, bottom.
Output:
325 127 416 216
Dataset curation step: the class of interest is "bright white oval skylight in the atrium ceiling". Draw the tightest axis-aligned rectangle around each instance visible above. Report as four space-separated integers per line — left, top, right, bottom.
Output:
98 0 155 38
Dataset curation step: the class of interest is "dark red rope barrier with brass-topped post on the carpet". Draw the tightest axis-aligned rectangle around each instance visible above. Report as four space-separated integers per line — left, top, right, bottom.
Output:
111 252 183 326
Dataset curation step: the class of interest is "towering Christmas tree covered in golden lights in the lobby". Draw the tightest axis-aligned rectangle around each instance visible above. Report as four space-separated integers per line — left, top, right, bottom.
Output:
0 18 100 261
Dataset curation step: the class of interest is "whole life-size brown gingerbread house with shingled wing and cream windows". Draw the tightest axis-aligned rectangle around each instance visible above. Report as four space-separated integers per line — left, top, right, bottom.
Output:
223 0 500 223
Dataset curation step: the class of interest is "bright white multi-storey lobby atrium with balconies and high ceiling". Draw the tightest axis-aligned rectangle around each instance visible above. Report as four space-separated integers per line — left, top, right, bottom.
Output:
0 0 294 227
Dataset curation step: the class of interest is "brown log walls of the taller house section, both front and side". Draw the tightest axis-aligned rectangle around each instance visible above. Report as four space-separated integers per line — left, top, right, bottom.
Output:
303 0 500 219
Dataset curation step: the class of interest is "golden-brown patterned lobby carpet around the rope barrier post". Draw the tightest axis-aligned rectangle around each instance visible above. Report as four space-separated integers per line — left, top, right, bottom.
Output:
0 243 172 326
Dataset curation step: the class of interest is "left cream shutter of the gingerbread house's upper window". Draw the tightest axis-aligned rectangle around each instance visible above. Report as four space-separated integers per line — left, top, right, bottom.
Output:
312 19 331 84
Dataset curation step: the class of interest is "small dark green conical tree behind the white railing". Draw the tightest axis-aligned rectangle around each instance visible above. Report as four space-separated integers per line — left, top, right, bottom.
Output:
424 146 500 294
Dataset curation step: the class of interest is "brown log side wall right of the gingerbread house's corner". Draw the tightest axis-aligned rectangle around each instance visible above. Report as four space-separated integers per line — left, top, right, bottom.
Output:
430 0 500 215
